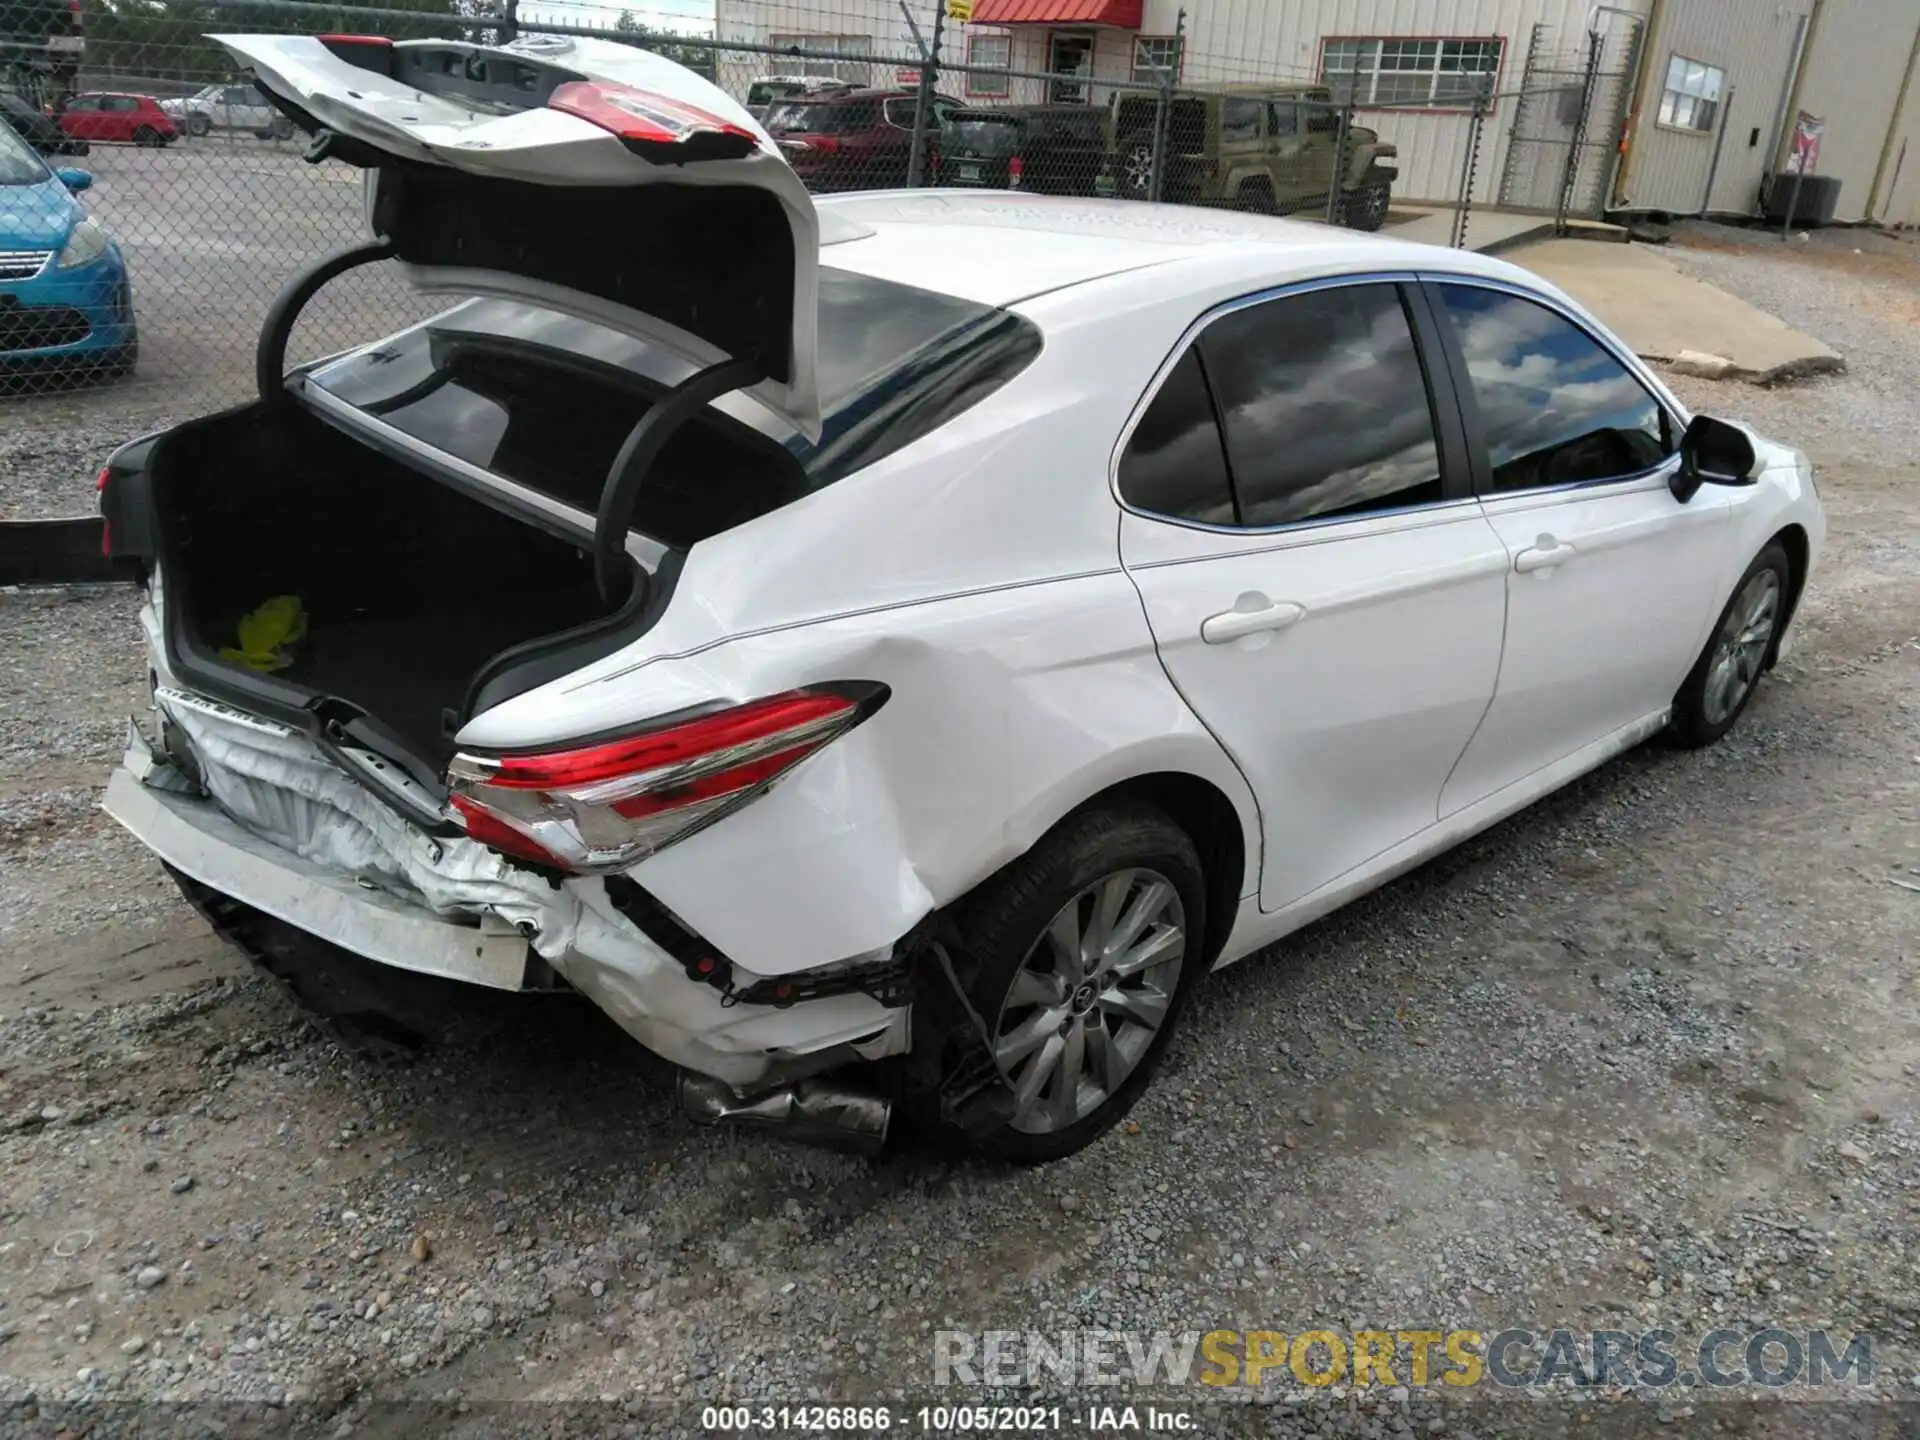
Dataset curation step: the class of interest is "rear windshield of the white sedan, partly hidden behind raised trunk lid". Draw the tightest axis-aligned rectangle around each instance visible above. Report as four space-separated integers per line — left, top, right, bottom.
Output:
307 267 1041 543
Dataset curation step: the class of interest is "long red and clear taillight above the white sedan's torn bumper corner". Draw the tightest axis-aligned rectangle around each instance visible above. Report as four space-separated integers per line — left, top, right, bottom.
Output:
447 685 887 874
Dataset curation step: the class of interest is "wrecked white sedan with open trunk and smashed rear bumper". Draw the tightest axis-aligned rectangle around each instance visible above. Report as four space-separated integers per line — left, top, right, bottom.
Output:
102 36 1824 1162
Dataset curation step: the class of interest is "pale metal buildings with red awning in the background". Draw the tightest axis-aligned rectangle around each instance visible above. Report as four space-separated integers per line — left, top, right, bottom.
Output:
716 0 1920 223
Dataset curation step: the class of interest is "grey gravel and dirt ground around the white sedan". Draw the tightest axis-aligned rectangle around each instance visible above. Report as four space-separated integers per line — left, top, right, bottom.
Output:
0 232 1920 1436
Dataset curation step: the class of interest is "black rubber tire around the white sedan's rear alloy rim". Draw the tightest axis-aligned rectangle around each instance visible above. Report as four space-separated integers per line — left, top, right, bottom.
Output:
936 803 1208 1165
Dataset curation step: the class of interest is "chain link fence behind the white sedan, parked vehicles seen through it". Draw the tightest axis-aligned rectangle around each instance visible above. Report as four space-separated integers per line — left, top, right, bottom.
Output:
0 0 1589 422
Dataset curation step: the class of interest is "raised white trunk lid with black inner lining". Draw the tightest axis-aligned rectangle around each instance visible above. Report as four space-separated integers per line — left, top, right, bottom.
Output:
213 35 820 438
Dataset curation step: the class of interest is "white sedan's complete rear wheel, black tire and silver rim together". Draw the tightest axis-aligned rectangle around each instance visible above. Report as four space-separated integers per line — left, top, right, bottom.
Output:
940 804 1206 1164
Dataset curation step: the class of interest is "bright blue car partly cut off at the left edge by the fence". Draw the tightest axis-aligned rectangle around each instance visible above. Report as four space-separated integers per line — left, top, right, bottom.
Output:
0 121 138 376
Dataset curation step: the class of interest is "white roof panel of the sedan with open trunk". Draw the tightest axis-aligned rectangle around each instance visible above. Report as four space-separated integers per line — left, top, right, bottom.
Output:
818 190 1553 307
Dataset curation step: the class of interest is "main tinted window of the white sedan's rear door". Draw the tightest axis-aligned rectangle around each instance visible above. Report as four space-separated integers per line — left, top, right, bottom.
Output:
1200 284 1440 526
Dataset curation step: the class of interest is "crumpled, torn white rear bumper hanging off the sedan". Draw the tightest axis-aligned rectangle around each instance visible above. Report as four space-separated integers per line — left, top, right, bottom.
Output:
104 691 908 1089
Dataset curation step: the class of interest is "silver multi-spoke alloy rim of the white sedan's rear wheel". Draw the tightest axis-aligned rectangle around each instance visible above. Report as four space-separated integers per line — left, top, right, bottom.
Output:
993 870 1190 1135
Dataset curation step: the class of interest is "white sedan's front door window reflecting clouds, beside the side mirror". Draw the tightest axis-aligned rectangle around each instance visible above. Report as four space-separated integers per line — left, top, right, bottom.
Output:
1440 284 1672 490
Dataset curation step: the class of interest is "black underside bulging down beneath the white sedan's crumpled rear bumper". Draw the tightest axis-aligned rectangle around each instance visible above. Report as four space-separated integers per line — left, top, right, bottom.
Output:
167 866 520 1064
